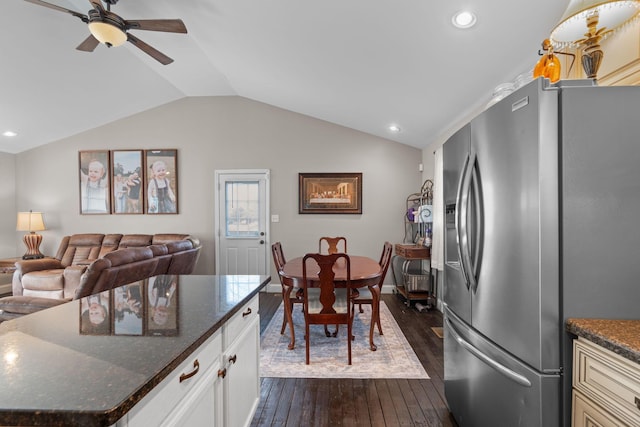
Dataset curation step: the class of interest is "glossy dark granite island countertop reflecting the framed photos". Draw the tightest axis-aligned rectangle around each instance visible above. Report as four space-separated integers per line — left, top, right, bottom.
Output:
0 275 270 426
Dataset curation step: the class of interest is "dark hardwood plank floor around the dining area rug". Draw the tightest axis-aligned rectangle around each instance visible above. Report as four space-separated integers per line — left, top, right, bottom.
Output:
251 292 456 427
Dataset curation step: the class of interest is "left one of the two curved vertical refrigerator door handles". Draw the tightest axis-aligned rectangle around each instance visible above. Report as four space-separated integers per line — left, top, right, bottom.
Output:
456 153 477 290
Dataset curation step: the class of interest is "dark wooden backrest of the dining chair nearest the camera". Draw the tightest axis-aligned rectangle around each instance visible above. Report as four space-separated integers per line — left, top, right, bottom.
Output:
302 253 351 316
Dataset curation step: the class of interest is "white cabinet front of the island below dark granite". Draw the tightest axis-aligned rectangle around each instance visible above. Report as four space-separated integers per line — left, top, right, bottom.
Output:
117 295 260 427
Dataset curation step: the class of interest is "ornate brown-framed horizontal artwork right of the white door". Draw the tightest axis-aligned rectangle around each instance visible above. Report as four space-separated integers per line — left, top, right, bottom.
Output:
298 173 362 214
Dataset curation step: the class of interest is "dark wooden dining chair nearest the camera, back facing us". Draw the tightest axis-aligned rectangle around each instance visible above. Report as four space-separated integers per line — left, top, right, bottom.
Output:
302 253 353 365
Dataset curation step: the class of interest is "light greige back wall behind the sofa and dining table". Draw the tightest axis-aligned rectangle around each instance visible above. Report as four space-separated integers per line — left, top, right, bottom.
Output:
12 97 422 283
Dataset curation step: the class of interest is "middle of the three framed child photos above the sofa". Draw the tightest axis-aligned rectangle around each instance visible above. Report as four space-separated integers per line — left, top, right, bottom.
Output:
111 150 145 214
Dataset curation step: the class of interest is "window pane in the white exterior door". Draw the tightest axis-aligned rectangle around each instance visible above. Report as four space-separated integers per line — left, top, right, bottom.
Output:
225 181 260 238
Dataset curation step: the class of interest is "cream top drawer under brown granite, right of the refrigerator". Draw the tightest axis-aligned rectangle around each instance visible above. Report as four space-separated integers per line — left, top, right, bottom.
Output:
573 338 640 425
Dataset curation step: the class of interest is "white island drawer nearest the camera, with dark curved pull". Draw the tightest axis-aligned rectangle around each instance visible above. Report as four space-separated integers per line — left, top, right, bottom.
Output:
128 332 222 427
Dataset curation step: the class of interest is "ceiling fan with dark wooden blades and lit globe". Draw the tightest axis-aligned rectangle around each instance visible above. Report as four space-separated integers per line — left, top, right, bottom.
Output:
25 0 187 65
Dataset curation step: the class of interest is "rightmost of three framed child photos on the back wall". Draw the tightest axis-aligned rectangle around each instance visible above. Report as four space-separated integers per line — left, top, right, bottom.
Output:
144 150 178 214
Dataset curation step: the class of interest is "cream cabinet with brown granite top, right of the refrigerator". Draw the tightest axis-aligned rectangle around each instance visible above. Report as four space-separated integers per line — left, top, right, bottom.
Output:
567 319 640 427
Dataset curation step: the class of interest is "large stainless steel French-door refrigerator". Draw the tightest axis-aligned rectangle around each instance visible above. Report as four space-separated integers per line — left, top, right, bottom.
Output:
443 79 640 427
